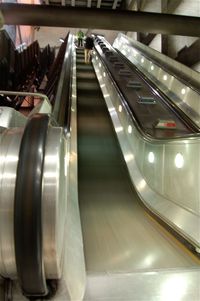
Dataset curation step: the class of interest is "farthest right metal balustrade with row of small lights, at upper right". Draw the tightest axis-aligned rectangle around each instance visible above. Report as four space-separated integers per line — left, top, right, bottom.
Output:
113 34 200 127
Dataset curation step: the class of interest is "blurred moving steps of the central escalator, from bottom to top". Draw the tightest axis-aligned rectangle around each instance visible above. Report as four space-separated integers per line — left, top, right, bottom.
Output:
77 50 199 273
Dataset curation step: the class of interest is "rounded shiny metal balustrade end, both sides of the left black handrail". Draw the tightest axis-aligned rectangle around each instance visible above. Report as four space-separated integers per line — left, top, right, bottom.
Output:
0 122 67 279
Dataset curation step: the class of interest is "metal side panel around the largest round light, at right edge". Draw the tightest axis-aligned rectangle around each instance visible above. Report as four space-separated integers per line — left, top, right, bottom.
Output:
163 140 200 211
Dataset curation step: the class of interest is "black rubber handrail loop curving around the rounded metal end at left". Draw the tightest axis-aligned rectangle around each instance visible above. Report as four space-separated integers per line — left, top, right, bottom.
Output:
14 114 49 297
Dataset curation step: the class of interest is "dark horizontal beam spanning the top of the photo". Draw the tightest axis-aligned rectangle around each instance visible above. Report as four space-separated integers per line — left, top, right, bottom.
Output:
0 3 200 37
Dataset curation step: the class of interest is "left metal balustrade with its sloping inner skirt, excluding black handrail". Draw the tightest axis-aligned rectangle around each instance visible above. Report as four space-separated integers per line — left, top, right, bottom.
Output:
0 39 86 301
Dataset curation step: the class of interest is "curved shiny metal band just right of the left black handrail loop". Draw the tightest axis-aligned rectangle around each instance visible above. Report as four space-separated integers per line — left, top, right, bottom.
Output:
42 128 67 279
